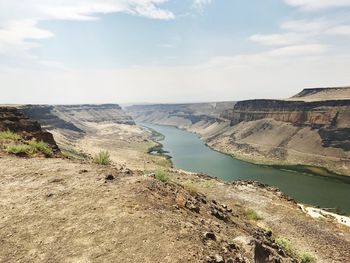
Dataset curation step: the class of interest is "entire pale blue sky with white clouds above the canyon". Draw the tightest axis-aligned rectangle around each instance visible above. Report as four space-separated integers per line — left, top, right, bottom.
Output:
0 0 350 104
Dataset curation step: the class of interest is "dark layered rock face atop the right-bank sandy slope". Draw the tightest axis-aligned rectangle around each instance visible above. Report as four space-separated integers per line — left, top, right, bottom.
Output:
221 100 350 151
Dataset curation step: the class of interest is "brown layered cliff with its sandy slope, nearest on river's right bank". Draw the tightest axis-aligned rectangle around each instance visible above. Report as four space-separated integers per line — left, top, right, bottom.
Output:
209 95 350 174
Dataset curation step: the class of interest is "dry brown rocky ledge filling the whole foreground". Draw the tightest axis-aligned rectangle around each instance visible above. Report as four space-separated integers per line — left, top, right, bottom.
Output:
0 155 350 262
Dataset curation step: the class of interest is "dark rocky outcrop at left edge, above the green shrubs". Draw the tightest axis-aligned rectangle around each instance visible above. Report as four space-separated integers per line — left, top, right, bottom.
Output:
0 107 59 152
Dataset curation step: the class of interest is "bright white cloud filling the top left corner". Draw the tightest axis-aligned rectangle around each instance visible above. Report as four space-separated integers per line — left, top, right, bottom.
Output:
0 0 175 56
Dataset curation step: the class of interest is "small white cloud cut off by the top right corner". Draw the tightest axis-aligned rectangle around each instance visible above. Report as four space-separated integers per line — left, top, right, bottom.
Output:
285 0 350 11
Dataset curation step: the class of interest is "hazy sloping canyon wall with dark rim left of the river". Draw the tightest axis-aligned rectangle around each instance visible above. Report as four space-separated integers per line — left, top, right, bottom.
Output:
19 104 139 160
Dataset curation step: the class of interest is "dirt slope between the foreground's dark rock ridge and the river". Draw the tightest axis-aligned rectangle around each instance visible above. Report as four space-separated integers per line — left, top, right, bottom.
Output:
174 175 350 263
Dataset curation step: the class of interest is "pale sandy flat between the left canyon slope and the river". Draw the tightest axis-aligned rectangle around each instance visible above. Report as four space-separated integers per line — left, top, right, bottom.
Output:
51 122 171 170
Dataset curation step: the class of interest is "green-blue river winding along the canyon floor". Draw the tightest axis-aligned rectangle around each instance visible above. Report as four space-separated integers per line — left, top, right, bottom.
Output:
142 123 350 214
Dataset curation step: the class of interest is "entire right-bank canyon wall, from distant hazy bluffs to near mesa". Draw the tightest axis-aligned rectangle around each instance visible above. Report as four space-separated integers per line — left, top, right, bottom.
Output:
128 88 350 175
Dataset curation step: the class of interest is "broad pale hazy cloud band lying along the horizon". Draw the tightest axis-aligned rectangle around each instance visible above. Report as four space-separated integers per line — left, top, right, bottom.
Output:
0 50 350 103
